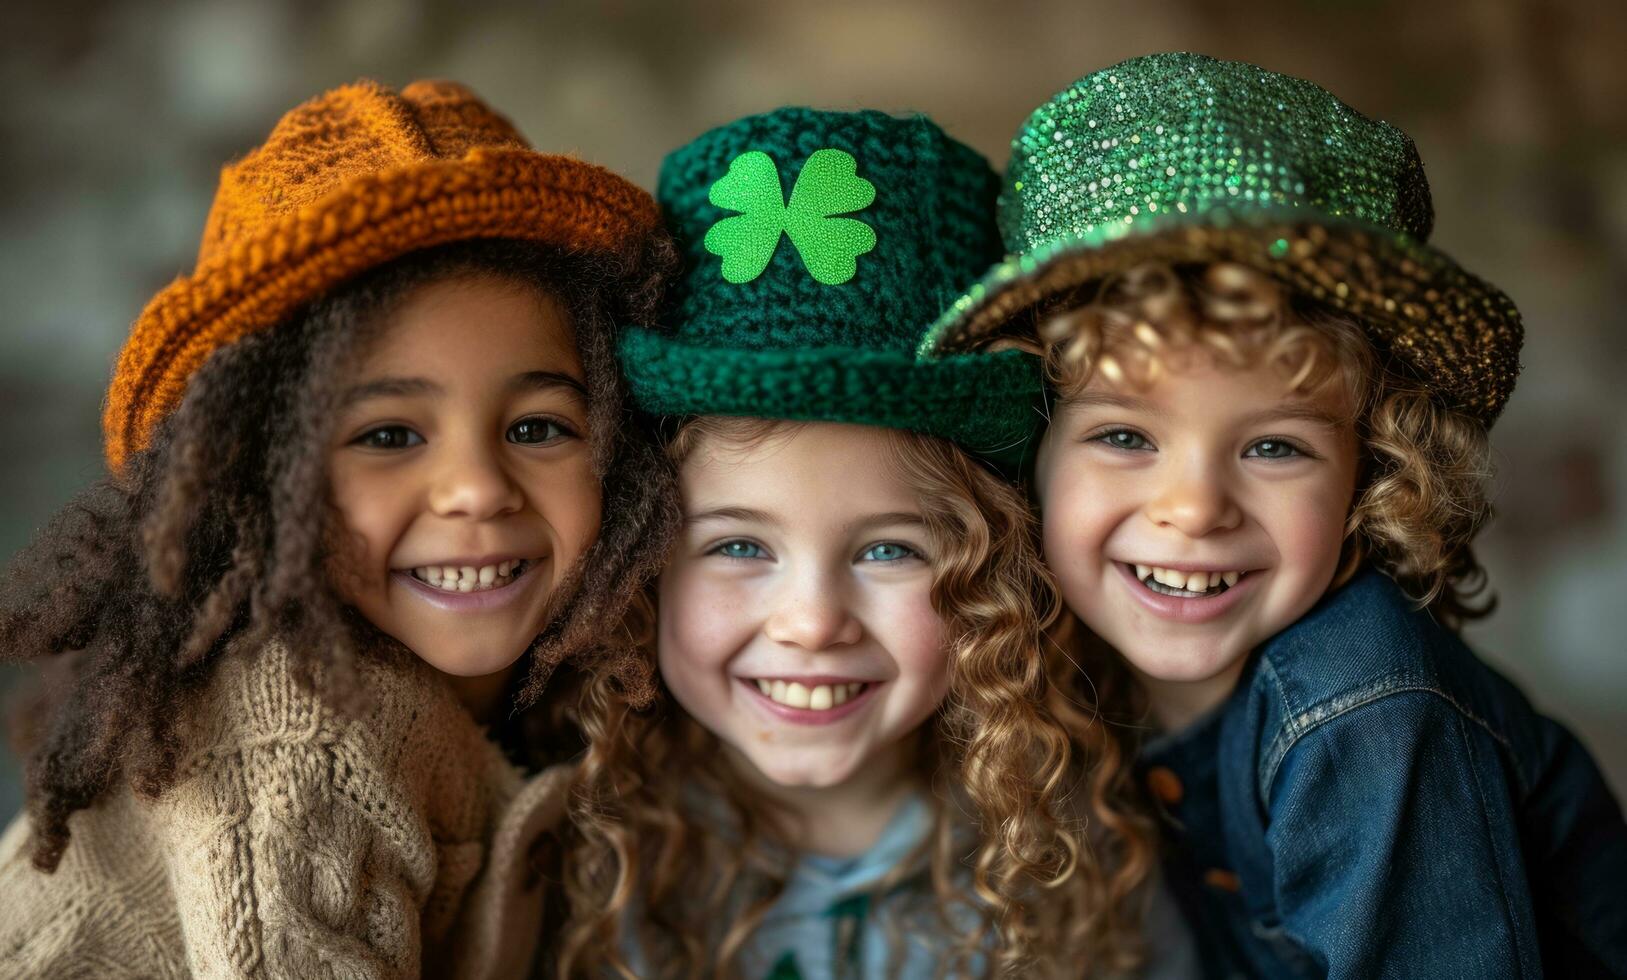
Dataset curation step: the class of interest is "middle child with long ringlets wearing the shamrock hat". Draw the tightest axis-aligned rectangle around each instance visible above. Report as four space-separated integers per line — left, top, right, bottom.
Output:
556 109 1171 978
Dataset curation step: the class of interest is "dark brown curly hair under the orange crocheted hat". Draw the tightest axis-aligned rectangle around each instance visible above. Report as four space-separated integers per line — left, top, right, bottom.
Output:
0 236 677 871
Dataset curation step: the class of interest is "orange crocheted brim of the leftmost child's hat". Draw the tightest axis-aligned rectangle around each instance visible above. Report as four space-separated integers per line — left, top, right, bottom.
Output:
103 148 661 470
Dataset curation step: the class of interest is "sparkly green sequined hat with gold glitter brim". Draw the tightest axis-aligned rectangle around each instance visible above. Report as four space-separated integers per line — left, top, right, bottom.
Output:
921 54 1523 425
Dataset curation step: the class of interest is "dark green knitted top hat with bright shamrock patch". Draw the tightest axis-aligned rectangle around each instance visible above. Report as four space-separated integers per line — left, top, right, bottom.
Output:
620 107 1041 462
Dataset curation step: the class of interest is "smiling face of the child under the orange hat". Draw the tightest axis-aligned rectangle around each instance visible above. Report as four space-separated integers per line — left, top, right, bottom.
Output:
329 277 600 677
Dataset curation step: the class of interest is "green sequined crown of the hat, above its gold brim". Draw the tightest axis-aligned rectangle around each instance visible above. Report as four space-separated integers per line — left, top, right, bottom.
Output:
999 54 1432 252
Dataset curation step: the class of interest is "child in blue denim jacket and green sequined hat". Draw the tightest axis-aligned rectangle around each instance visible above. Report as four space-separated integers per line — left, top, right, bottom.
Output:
924 54 1627 978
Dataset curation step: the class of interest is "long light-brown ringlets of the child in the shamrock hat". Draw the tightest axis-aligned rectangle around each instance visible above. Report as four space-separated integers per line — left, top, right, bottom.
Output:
552 417 1154 978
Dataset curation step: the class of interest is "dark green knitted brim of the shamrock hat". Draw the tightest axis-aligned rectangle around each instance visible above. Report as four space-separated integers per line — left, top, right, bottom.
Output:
622 327 1043 469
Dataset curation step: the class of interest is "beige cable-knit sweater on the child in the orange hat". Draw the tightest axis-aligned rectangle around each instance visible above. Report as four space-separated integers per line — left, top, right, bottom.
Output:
0 645 569 980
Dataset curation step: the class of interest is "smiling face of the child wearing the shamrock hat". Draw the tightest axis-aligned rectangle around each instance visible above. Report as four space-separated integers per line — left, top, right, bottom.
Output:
659 423 949 788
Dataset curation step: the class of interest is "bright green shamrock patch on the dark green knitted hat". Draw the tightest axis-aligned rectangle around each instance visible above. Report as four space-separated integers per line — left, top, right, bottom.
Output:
706 148 875 287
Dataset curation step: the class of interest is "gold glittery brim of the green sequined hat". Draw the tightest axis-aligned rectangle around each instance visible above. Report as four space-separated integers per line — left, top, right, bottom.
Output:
918 207 1524 425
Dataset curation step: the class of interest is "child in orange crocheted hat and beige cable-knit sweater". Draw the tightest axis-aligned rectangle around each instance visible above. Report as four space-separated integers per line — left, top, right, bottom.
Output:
0 83 675 978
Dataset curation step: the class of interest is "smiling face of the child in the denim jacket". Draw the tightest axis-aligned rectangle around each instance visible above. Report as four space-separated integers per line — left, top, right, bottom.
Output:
1035 348 1357 728
